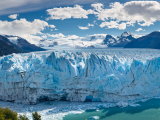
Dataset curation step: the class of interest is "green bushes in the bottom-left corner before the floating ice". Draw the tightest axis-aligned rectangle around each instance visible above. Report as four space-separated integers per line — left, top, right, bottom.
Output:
0 107 41 120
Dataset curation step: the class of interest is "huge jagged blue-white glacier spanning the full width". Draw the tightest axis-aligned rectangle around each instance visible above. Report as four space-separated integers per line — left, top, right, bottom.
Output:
0 49 160 104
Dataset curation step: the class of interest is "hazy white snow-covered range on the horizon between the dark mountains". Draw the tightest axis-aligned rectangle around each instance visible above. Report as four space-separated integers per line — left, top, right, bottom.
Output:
42 33 106 48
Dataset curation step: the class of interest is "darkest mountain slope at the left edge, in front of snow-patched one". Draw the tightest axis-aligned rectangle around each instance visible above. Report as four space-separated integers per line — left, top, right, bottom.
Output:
0 35 19 56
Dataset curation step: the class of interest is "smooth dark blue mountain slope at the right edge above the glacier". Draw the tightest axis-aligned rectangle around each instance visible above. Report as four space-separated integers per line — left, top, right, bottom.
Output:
124 31 160 49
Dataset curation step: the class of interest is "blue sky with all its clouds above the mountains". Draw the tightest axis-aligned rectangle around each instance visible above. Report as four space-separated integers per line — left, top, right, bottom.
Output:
0 0 160 44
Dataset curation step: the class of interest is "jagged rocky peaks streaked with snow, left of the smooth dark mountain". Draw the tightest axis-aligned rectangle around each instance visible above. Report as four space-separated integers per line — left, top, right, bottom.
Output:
102 32 135 47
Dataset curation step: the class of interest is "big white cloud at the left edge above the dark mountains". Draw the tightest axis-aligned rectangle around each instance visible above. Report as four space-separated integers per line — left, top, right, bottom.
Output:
0 18 55 44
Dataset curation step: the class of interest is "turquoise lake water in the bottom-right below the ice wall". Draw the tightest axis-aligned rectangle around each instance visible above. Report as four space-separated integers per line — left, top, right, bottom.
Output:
63 99 160 120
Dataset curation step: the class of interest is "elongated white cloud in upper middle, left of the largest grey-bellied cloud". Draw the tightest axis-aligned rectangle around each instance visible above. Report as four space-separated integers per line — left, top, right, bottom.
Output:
47 5 94 20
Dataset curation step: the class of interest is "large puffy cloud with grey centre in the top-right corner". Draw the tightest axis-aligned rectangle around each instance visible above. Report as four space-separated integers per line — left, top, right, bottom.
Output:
91 1 160 29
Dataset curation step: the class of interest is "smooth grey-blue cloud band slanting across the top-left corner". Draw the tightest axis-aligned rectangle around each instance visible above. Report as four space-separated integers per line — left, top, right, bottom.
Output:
0 0 103 15
